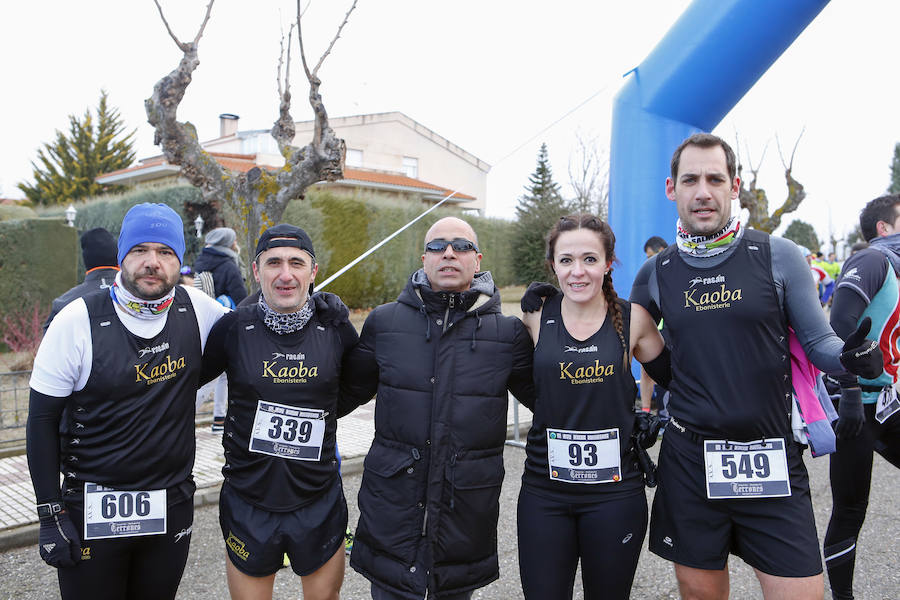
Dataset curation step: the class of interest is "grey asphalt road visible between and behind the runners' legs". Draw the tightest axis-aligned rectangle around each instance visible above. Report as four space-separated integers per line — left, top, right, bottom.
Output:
0 447 900 600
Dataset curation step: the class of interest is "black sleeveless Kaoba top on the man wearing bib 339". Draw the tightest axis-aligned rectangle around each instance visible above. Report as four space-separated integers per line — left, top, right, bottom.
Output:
210 305 352 512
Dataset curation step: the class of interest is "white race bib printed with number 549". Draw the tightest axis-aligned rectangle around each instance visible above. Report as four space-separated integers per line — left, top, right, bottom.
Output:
703 438 791 500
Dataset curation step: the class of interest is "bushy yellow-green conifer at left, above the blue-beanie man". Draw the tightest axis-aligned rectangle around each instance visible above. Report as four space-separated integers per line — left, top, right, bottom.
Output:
18 90 135 205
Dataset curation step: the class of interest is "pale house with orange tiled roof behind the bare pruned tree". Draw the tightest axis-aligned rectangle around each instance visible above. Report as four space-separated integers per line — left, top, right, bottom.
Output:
97 112 491 215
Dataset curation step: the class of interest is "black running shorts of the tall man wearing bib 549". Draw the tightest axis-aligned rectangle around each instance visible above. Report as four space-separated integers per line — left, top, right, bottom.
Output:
650 426 822 577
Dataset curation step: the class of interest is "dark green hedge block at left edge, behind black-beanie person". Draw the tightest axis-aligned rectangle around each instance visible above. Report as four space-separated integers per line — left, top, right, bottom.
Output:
0 219 81 316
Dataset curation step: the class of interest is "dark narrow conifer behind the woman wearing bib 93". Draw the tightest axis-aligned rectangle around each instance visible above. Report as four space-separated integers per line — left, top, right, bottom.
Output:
514 144 568 283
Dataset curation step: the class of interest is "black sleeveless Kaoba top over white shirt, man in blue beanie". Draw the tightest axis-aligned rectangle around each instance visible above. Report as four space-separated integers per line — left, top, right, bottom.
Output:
60 286 201 496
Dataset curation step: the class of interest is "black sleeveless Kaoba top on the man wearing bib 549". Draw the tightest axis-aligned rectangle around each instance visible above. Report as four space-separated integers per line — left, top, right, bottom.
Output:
656 229 791 441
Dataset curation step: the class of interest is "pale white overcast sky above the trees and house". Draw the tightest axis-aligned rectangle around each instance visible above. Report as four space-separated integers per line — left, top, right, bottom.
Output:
0 0 900 248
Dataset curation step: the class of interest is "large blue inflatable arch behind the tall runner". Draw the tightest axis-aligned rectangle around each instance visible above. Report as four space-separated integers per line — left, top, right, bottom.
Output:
609 0 828 297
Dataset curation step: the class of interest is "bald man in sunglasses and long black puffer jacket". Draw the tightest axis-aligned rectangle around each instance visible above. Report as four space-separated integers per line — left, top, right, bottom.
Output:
338 217 534 600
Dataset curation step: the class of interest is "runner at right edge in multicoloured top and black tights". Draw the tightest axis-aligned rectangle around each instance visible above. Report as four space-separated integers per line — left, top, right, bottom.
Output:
824 194 900 600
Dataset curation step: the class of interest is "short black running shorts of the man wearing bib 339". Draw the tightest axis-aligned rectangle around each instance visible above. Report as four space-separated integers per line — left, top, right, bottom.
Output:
219 477 347 577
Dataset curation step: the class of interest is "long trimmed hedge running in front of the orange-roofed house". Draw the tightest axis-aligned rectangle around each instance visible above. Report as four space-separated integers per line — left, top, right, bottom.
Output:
17 186 516 307
